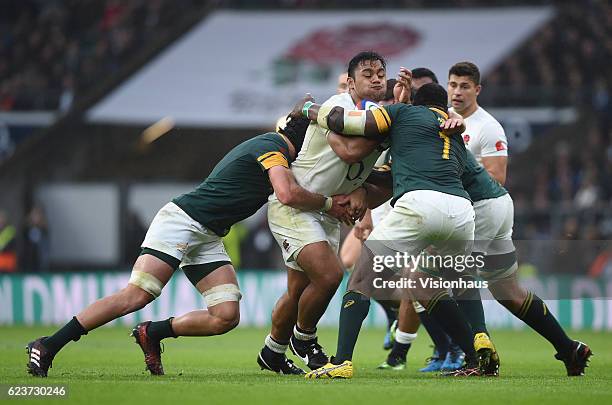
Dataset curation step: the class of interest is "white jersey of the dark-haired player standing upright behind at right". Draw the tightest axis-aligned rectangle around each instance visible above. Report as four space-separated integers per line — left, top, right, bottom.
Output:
451 106 508 163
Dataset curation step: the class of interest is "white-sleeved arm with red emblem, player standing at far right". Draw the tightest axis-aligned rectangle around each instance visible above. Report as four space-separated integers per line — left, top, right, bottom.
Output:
480 121 508 186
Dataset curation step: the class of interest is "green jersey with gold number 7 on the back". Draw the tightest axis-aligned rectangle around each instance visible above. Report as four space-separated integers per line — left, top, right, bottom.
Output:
385 104 470 204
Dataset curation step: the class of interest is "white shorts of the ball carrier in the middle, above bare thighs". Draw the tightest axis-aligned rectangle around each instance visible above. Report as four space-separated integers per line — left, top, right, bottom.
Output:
268 198 340 271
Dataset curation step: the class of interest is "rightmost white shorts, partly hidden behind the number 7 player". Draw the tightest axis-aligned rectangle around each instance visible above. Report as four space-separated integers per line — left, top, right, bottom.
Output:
474 194 515 255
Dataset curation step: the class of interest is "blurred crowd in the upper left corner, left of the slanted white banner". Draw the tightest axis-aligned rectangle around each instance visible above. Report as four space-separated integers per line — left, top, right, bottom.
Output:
0 0 205 111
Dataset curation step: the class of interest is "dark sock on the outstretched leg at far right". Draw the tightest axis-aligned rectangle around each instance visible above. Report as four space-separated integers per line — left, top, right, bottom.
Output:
502 291 573 353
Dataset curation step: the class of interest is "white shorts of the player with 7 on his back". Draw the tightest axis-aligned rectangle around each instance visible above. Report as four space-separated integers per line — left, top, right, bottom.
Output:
366 190 474 268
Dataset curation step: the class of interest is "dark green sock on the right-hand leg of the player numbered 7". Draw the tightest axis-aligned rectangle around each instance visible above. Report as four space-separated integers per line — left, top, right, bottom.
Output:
426 291 477 365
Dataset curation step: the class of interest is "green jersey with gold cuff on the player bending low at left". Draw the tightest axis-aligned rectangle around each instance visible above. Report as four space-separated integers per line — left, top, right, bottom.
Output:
172 132 290 236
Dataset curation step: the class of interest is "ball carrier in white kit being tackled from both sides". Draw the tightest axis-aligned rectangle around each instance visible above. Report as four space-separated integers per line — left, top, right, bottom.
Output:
257 52 412 374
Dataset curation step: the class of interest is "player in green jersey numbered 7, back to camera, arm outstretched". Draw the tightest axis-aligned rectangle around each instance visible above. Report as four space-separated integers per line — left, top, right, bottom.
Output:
294 84 480 378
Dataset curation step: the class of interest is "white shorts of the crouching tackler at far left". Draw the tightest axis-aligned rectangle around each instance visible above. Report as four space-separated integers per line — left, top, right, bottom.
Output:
142 202 230 268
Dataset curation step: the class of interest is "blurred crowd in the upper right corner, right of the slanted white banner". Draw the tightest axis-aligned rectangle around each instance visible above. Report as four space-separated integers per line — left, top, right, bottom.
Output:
484 0 612 109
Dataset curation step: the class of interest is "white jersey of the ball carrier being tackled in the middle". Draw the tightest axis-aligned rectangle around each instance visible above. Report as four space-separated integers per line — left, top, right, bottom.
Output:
291 93 380 196
